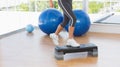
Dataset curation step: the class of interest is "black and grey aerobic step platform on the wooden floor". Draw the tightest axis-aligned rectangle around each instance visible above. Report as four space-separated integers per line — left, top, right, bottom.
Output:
55 43 98 60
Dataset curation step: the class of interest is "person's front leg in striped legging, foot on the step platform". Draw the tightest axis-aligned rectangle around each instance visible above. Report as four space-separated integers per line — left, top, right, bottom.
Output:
59 0 79 47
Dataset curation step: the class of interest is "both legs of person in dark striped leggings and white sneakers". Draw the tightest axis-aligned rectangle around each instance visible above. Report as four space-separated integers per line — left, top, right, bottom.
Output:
50 0 79 47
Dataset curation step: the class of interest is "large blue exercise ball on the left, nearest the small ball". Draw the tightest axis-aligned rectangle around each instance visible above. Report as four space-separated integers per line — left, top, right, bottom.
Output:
38 8 63 35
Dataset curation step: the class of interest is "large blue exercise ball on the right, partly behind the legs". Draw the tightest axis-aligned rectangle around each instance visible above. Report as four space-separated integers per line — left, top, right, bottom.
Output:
65 10 91 36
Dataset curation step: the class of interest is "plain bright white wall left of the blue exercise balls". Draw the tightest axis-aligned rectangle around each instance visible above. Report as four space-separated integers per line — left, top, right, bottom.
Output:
0 11 40 35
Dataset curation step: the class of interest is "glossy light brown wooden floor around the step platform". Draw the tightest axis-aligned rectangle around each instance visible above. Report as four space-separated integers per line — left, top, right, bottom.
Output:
0 29 120 67
